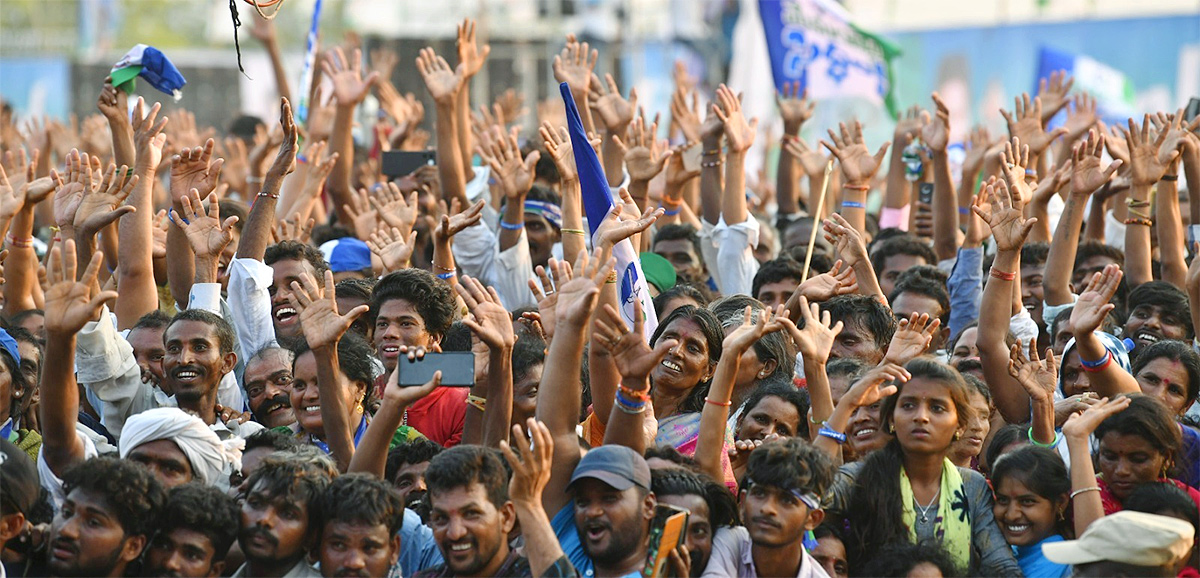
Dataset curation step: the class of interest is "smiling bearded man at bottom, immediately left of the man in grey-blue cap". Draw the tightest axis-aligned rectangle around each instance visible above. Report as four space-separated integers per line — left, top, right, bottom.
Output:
416 445 532 578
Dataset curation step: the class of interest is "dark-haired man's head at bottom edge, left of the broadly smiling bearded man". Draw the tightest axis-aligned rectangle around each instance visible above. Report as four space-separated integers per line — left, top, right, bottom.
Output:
314 474 404 578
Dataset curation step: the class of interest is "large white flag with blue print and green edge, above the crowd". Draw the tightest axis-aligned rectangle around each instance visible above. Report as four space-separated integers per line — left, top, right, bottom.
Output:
758 0 900 116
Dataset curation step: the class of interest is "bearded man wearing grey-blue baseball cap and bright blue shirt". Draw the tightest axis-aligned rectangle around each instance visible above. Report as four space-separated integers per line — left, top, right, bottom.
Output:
551 445 658 577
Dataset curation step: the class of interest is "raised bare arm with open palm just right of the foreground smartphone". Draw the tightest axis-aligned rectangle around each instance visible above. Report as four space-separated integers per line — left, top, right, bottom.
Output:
454 276 517 447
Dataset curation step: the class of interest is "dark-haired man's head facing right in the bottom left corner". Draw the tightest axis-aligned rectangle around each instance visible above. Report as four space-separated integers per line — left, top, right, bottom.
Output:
46 458 167 577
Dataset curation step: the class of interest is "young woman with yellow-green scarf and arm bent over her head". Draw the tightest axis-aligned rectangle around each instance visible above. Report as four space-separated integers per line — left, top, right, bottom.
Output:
816 357 1020 576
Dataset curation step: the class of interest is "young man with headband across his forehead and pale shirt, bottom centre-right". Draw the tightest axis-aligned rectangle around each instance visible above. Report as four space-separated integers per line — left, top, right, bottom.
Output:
703 438 834 578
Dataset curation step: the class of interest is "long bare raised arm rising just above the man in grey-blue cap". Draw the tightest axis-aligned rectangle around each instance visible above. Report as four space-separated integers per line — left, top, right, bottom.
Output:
536 251 616 513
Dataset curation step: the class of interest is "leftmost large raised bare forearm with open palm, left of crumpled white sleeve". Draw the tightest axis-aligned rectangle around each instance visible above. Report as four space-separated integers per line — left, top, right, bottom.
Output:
40 239 116 476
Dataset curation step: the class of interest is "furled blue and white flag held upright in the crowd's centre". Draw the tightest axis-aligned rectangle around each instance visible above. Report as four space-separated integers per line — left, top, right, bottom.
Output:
559 83 659 339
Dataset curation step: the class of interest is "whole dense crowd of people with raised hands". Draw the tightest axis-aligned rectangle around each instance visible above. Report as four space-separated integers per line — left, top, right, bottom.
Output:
0 12 1200 578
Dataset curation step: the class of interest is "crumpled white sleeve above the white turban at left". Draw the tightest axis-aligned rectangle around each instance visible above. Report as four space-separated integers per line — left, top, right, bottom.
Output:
76 306 157 439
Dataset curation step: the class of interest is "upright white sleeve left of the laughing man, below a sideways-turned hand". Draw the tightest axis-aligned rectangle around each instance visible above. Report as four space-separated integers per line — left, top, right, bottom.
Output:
227 259 277 361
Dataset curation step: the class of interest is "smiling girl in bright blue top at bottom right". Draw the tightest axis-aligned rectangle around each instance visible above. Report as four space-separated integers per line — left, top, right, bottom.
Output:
991 446 1070 578
